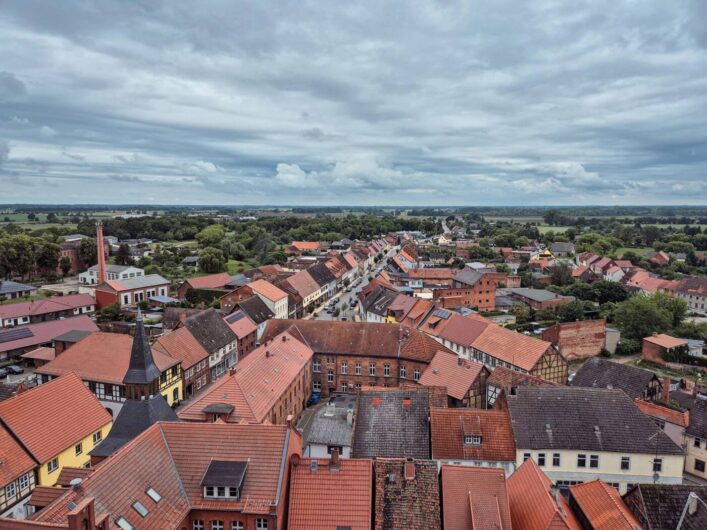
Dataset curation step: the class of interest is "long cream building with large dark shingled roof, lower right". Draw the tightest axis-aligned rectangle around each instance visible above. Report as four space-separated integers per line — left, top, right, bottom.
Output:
507 386 685 493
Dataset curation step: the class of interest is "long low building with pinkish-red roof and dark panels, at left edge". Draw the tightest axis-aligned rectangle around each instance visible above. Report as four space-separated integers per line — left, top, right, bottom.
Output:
0 315 98 361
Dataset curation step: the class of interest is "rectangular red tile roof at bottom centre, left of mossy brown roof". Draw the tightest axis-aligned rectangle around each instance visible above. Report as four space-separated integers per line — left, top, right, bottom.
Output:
288 458 373 530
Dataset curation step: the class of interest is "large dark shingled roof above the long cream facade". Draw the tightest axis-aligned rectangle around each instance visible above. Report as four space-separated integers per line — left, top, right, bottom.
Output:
507 386 683 455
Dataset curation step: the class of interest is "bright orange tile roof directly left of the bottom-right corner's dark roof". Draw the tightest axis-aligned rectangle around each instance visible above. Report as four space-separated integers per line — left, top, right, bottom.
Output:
570 480 641 530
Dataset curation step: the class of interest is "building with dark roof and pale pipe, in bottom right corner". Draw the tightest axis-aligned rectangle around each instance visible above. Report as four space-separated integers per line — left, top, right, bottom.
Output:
623 484 707 530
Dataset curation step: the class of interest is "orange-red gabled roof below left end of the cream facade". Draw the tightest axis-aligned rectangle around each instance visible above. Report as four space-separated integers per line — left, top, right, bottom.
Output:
507 458 581 530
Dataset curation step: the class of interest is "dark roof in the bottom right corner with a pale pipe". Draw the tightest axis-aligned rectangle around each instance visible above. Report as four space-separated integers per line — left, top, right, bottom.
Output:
624 484 707 530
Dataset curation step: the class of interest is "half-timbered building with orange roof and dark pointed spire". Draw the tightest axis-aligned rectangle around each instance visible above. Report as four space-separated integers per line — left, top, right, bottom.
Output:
35 316 182 416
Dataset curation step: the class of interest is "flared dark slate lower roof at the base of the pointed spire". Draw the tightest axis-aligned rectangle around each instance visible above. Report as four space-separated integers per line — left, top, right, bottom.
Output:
89 394 180 458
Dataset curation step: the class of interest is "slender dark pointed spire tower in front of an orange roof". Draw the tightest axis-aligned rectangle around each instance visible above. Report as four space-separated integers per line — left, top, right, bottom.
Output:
123 309 161 399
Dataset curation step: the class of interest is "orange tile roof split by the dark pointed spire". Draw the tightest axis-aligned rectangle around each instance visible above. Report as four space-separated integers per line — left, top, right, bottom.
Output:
37 331 180 385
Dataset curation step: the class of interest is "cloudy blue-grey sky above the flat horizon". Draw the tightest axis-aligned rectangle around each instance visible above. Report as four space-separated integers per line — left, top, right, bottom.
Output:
0 0 707 206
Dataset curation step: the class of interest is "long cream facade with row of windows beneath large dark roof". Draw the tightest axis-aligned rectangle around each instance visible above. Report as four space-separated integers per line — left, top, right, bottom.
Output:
516 449 685 495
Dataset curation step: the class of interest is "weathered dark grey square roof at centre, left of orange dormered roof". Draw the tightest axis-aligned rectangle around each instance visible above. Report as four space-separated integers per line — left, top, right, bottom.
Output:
353 388 431 458
